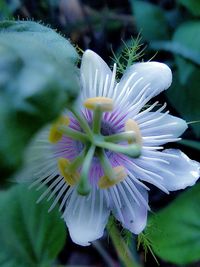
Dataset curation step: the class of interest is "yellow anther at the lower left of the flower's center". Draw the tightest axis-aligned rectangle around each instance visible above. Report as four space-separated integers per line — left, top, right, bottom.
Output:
58 158 80 186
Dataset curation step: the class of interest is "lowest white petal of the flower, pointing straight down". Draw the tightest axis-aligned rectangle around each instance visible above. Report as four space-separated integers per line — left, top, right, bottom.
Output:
63 188 109 246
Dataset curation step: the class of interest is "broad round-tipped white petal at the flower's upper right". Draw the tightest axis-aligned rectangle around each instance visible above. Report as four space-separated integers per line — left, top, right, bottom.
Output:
118 62 172 109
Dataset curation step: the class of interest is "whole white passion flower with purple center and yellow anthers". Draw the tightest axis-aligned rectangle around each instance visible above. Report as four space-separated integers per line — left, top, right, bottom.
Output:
22 50 199 246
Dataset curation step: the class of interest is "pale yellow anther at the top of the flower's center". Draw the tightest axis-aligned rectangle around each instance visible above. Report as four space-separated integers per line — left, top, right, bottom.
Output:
84 97 113 112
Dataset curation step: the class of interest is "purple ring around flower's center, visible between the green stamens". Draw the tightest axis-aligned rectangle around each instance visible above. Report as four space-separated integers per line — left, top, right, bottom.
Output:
53 110 127 184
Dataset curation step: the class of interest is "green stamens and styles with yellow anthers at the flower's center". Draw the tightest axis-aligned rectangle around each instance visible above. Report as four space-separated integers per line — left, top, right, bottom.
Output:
49 97 142 195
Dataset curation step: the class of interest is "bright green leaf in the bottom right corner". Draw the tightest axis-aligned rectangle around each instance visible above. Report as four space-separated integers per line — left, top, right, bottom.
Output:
146 184 200 265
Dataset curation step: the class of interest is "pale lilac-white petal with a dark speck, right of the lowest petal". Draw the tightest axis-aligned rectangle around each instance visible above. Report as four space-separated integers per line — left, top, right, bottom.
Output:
112 182 148 234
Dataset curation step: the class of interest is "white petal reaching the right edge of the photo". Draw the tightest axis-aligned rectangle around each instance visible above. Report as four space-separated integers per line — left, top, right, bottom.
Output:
138 149 200 192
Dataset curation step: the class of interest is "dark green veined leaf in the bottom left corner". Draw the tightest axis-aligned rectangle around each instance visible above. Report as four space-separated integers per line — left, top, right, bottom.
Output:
0 185 66 267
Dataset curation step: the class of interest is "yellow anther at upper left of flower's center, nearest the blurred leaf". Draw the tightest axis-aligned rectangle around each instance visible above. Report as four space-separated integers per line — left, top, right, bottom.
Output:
49 116 70 144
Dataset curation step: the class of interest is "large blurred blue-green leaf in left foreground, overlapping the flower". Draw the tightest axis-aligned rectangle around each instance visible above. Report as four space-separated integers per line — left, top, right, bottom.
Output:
0 21 78 179
